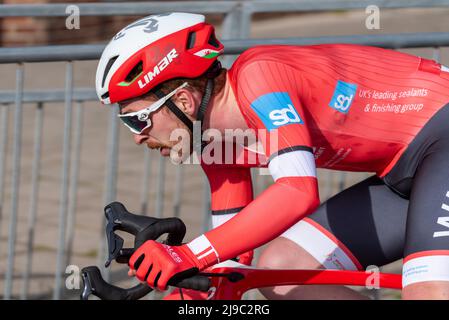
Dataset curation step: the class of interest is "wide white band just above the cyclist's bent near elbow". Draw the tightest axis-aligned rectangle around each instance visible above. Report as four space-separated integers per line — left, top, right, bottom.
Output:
268 150 316 181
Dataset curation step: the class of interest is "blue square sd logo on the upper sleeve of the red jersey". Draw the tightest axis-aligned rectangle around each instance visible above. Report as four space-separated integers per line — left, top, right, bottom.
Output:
251 92 304 131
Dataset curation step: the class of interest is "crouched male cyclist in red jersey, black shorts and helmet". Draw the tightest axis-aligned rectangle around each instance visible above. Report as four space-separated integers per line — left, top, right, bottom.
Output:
96 13 449 299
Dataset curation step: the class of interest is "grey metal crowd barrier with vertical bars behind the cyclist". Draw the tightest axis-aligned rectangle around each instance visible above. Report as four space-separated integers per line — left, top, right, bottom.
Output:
0 0 449 299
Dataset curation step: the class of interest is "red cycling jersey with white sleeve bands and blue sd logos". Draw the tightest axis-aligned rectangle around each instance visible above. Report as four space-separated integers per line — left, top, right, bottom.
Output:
186 44 449 261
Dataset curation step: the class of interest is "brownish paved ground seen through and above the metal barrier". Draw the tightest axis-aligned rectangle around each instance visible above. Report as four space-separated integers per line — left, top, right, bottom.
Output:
0 9 449 298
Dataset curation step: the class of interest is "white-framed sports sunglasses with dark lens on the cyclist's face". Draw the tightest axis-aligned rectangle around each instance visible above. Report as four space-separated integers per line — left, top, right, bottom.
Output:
117 82 188 134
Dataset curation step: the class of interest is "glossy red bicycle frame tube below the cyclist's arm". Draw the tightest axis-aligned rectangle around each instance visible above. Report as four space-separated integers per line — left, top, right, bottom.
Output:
205 267 402 300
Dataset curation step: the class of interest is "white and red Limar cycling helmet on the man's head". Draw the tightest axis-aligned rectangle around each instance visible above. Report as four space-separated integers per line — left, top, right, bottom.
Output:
95 12 224 104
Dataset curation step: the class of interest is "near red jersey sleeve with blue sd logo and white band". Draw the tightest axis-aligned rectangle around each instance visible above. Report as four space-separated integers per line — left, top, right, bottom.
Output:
185 61 319 265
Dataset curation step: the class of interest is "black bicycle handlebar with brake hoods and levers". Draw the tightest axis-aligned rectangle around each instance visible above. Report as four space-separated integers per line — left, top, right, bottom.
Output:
81 202 210 300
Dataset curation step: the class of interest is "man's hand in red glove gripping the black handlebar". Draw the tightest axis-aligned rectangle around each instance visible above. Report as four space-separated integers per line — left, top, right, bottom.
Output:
129 240 201 290
